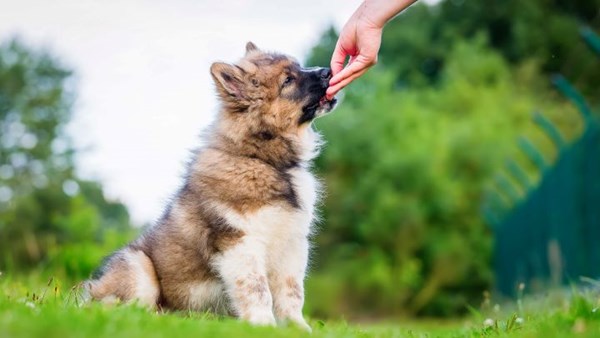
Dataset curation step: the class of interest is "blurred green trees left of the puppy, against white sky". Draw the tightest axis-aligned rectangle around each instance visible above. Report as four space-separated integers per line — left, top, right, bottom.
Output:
0 41 131 277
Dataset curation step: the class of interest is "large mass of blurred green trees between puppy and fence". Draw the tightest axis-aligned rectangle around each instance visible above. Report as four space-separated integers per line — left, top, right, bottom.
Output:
307 0 600 316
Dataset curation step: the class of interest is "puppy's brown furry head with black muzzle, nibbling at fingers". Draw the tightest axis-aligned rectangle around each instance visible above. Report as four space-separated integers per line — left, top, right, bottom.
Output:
210 42 336 132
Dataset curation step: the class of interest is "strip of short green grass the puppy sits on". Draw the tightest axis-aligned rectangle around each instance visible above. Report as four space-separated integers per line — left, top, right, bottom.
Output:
0 276 600 338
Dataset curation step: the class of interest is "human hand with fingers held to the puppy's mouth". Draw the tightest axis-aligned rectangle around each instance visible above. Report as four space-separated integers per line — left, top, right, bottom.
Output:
327 7 383 99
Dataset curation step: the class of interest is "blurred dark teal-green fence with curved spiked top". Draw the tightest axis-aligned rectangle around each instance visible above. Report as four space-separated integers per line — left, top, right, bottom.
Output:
483 29 600 295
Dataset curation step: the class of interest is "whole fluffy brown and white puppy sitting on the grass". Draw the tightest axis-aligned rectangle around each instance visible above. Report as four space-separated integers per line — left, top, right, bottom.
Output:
86 43 335 329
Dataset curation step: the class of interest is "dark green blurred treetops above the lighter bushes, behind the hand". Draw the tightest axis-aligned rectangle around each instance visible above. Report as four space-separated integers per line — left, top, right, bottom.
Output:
308 0 600 103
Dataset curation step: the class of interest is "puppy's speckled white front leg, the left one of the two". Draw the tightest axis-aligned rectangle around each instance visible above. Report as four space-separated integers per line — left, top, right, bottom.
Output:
214 235 275 325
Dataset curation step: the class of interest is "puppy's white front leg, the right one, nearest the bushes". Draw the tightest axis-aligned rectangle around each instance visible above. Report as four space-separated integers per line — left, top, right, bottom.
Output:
269 236 311 331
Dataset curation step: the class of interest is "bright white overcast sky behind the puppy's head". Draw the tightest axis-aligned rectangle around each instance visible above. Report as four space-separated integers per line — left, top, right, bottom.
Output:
0 0 422 224
